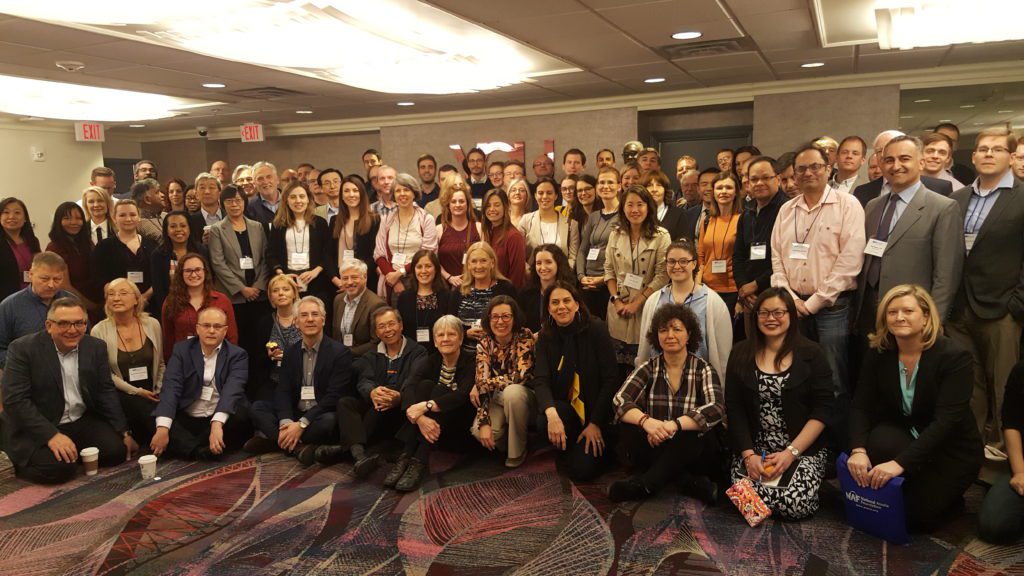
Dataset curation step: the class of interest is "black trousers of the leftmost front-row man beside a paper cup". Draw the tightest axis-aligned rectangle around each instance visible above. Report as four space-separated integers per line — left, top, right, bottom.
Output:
14 412 127 484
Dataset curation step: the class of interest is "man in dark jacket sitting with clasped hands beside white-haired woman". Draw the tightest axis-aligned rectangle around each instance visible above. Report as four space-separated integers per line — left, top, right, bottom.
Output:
316 306 427 479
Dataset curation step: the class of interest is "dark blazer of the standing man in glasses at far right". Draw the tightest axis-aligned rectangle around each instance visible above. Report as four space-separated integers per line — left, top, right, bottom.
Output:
951 179 1024 322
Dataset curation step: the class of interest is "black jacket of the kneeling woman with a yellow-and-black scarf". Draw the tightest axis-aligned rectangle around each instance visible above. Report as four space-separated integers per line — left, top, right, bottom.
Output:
527 317 622 426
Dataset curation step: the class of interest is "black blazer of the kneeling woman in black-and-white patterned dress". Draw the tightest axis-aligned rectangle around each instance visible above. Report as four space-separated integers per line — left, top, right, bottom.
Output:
725 338 836 455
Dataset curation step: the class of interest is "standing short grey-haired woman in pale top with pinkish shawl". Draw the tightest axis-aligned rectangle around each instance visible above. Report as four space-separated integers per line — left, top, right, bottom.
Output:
374 173 437 302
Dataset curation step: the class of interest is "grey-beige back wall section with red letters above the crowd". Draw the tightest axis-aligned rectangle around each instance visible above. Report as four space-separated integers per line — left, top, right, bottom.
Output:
381 108 637 178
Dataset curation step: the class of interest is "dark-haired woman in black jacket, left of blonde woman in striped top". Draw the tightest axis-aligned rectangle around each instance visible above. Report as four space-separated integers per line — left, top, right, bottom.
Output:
397 250 450 355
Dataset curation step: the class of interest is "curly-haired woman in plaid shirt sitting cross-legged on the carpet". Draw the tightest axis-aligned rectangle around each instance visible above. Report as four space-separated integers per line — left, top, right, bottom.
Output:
608 303 725 501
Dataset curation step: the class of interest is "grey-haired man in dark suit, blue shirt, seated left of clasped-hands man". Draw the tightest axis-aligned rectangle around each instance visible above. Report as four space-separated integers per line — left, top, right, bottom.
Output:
245 296 352 466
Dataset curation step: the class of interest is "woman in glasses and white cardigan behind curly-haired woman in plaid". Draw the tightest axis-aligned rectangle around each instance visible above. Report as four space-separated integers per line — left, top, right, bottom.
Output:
636 240 732 374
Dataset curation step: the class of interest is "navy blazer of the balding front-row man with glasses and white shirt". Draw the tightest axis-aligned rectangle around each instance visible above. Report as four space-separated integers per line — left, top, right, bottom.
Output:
153 337 249 419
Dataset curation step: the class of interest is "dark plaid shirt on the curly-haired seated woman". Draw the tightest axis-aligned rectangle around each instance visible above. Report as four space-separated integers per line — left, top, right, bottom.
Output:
612 354 725 434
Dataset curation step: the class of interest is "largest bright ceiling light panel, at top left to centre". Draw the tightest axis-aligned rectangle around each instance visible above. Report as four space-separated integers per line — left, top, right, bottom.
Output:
0 0 580 94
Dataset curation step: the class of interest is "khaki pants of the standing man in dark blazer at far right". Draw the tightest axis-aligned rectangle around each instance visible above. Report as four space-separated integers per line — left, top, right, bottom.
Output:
946 307 1021 440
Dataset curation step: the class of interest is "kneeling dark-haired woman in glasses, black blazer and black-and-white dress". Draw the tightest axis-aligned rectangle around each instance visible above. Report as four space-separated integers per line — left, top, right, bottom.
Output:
725 288 835 520
